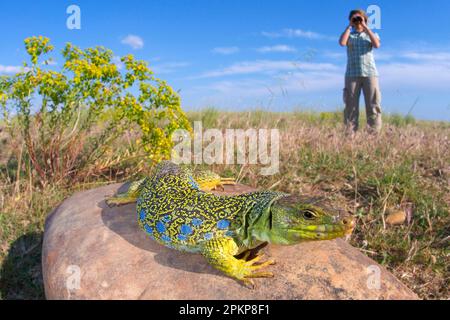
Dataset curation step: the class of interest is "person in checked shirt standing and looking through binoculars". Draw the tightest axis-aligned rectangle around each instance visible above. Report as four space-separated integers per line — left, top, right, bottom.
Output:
339 10 382 132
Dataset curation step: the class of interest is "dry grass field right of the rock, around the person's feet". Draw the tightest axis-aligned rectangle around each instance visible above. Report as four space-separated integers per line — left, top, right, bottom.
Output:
193 110 450 299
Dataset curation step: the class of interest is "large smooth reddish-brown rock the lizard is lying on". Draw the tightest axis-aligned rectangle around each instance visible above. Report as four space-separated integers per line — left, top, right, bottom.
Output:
42 184 417 299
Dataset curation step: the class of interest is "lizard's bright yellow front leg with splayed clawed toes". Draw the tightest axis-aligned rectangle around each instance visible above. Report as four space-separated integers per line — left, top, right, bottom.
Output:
202 238 275 287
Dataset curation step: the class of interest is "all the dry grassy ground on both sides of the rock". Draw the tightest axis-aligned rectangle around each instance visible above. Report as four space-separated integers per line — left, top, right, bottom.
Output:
0 109 450 299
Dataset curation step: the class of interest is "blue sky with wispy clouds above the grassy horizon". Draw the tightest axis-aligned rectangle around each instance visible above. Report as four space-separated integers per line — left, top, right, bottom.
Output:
0 0 450 121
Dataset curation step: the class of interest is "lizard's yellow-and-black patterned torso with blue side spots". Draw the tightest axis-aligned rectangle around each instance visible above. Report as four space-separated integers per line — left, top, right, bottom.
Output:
137 161 280 252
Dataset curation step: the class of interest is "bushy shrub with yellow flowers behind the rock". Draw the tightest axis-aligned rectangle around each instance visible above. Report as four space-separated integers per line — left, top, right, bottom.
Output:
0 36 190 184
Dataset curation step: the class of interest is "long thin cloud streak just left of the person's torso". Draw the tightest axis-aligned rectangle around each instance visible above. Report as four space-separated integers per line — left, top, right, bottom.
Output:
194 60 337 78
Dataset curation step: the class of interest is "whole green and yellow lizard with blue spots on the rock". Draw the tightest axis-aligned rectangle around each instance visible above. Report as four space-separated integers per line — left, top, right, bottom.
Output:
107 161 354 286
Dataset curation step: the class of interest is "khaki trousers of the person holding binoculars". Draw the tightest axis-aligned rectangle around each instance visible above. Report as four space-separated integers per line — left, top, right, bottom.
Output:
344 77 381 132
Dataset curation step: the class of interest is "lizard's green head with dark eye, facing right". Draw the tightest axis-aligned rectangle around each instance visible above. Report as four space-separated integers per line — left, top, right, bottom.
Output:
269 196 355 244
